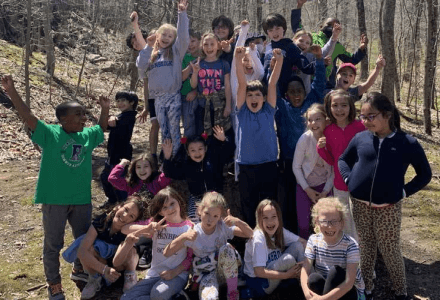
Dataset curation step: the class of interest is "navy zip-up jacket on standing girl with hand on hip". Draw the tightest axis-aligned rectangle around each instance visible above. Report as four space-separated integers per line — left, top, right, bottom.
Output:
338 131 432 204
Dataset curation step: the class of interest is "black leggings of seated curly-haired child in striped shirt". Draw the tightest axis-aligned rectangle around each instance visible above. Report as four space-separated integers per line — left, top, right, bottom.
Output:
307 266 357 300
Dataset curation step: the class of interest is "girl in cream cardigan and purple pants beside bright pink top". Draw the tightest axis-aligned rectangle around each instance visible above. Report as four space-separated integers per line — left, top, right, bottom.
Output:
293 103 335 239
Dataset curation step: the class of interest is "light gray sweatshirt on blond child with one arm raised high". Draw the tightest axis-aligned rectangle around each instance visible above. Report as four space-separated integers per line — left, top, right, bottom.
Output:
136 11 189 98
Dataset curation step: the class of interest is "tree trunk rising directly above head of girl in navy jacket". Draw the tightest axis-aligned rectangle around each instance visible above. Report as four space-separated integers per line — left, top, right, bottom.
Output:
379 0 398 103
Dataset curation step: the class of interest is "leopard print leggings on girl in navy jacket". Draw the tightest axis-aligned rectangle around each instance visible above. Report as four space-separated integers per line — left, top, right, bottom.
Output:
351 198 406 295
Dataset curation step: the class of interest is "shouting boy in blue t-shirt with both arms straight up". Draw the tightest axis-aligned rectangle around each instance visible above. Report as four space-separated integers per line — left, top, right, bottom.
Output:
235 47 283 226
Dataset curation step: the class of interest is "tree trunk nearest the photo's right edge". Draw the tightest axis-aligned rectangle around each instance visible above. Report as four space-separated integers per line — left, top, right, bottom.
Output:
423 0 438 135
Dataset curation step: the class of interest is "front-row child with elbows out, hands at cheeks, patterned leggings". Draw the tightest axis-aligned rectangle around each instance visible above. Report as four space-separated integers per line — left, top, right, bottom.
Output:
164 192 252 300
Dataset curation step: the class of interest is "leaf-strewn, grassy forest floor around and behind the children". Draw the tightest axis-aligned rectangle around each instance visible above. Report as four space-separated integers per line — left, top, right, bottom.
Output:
0 35 440 300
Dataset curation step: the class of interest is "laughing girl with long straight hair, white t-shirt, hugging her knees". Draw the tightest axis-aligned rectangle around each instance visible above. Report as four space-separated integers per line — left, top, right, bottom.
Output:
241 200 306 299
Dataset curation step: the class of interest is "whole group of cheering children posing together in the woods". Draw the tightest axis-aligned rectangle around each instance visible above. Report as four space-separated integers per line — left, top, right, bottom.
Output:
2 0 431 300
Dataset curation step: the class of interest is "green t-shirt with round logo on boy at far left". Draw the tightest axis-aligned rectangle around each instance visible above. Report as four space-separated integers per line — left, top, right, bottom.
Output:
32 121 104 205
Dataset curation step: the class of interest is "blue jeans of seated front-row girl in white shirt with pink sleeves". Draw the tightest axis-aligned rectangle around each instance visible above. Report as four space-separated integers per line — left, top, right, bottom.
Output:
121 276 187 300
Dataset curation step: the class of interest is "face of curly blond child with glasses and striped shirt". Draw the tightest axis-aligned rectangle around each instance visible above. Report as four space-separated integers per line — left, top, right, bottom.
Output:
316 208 344 245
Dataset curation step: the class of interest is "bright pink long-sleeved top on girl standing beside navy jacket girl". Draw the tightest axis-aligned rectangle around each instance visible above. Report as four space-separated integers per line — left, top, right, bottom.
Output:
316 120 365 191
